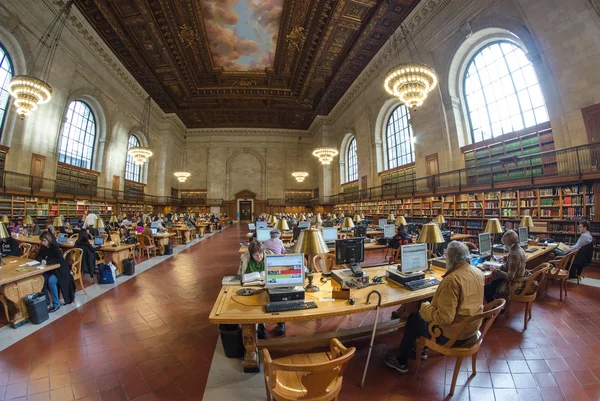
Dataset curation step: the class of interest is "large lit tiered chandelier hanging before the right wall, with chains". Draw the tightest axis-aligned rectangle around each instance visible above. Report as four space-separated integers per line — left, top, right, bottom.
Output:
383 18 438 110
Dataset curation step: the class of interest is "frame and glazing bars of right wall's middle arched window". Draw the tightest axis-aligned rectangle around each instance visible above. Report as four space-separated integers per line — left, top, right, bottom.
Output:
384 103 416 171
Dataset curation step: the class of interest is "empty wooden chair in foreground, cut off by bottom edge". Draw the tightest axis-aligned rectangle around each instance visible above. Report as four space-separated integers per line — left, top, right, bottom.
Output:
262 338 356 401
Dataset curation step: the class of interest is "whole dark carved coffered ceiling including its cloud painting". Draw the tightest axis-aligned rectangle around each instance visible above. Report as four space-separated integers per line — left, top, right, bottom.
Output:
75 0 419 129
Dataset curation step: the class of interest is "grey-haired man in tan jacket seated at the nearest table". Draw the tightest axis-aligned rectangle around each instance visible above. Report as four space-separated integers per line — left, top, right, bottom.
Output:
384 241 484 373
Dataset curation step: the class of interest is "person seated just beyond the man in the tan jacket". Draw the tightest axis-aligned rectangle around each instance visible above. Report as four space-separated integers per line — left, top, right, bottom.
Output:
484 230 527 302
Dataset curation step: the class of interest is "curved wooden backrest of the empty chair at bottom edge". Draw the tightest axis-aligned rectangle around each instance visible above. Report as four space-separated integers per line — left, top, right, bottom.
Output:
263 338 356 400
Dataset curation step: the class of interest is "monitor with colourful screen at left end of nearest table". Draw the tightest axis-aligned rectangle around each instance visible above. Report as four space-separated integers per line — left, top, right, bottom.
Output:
265 253 304 288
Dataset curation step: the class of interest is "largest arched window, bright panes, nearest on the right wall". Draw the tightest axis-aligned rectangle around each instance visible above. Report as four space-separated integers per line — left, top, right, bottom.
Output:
464 41 548 143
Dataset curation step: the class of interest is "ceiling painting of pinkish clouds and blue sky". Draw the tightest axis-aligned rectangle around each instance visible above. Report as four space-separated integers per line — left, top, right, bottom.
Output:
200 0 283 71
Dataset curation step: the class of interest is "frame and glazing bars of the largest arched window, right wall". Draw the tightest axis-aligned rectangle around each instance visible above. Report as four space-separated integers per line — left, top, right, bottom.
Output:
460 38 550 144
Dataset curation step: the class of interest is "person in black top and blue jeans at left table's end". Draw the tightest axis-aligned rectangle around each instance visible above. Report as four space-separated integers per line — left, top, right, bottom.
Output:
36 232 75 313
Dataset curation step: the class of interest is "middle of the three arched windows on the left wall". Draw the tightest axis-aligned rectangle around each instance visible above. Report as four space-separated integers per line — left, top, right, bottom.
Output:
58 100 96 169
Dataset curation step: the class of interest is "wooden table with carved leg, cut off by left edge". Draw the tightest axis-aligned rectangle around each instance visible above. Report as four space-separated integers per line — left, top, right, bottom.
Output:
0 256 60 329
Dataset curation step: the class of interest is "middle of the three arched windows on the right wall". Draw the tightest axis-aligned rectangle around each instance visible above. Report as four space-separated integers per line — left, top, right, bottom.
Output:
386 104 415 169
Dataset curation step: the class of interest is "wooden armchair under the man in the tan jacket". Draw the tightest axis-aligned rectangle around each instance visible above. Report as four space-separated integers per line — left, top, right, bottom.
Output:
416 298 506 396
